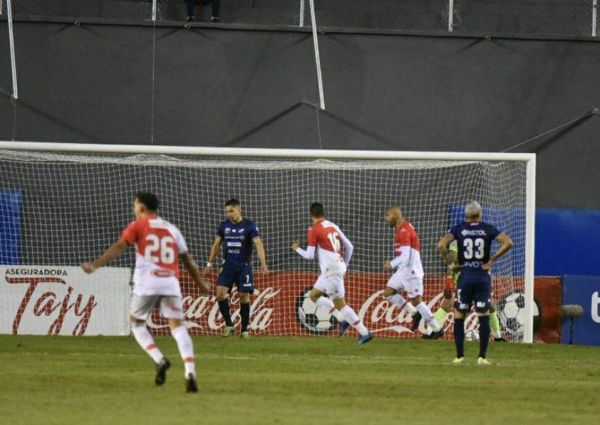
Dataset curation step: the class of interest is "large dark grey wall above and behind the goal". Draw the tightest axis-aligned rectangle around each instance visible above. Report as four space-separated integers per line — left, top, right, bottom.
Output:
0 21 600 209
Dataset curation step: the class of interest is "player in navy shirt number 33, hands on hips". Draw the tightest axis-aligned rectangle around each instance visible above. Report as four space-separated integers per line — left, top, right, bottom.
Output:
438 201 513 365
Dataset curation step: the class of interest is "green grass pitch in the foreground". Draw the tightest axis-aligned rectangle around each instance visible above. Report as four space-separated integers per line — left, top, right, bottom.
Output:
0 335 600 425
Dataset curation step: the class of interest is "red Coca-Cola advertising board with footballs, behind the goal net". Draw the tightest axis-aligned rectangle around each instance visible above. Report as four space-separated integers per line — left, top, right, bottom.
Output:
149 272 525 339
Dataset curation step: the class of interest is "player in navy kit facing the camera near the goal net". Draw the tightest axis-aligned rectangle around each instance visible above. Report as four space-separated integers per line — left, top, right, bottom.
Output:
204 199 269 338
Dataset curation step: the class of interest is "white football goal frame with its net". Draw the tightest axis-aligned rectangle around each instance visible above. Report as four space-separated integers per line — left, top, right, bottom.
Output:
0 142 536 343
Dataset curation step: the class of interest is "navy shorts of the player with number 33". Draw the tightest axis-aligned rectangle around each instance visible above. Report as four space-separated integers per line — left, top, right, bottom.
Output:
454 273 492 314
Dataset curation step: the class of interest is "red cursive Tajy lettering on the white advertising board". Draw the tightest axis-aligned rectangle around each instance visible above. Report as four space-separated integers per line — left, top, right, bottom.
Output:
5 270 98 335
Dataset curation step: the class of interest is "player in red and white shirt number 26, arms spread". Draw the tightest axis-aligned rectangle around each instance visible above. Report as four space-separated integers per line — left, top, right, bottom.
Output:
81 192 210 392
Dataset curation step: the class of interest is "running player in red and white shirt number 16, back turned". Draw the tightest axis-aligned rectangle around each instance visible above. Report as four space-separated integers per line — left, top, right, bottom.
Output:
292 202 373 344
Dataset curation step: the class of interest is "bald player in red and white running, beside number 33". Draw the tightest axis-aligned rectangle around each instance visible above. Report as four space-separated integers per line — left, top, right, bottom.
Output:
383 205 444 339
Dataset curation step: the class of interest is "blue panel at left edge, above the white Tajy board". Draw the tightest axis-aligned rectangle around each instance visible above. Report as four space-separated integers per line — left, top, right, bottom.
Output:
0 189 22 264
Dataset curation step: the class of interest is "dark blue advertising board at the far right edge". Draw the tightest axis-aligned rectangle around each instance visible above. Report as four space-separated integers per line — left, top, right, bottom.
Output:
560 275 600 346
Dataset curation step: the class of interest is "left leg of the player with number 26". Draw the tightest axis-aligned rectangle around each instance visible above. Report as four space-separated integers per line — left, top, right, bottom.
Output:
129 294 171 385
